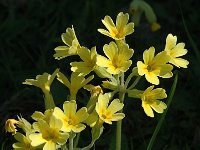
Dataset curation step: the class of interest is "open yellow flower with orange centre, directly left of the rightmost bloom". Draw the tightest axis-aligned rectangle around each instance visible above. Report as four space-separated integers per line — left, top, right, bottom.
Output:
137 47 173 85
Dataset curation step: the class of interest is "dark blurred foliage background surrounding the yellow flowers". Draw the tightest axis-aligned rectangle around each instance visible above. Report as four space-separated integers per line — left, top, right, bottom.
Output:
0 0 200 150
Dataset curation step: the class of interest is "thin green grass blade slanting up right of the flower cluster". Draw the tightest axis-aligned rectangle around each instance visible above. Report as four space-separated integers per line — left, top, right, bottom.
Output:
147 73 178 150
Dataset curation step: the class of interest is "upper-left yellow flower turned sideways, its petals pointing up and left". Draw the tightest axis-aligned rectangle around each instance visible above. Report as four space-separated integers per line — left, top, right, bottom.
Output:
54 26 81 60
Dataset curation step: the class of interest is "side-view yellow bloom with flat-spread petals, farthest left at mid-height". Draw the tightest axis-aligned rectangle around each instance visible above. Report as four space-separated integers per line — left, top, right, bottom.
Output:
23 69 59 93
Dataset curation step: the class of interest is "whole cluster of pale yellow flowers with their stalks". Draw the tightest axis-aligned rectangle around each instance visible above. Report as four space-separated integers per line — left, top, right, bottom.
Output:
5 12 189 150
